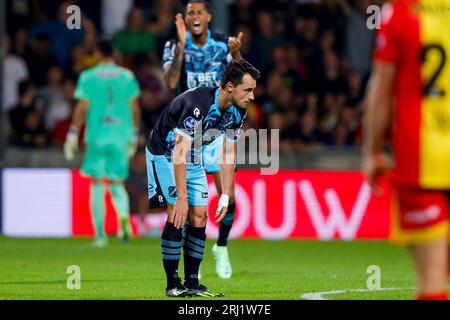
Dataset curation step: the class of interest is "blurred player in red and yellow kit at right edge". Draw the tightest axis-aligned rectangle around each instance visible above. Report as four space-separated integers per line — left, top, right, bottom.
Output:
364 0 450 300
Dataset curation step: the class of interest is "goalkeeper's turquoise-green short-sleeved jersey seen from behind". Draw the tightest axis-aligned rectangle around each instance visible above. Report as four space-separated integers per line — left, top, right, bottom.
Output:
74 63 140 145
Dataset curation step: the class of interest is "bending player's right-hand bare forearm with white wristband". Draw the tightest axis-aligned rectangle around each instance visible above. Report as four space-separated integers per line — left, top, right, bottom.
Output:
216 138 236 223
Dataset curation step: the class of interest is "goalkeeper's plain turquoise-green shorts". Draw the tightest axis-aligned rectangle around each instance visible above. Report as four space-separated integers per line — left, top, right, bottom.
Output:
81 143 130 181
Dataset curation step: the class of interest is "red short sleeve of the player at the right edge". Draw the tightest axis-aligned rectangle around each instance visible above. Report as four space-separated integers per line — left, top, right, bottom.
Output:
374 3 399 62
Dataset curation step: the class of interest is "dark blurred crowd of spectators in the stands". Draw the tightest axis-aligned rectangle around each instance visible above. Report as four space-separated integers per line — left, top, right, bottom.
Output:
2 0 382 219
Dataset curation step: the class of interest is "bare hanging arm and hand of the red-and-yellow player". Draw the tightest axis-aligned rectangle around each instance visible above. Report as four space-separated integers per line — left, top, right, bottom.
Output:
363 62 396 195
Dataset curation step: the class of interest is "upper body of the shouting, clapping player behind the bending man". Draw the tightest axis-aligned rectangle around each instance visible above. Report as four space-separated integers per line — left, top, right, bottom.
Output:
163 0 243 93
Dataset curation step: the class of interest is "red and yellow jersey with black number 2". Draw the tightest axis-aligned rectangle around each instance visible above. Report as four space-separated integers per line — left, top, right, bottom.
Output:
375 0 450 189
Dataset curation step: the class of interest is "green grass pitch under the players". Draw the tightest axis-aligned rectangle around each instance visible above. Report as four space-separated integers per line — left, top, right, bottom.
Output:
0 237 414 300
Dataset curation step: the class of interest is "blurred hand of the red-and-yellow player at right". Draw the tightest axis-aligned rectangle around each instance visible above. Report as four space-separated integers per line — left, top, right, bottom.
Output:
363 153 389 197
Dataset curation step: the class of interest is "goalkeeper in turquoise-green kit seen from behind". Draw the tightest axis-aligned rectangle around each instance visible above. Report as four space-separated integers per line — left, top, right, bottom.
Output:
64 40 140 247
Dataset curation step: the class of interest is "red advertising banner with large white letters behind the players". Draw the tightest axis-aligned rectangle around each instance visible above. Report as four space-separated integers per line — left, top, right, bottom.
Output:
72 170 391 240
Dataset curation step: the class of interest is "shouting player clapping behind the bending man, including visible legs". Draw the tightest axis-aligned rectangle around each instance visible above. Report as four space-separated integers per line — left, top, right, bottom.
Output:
163 0 243 279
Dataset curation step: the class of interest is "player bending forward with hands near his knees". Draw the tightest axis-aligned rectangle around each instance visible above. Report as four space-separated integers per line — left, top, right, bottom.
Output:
146 60 259 297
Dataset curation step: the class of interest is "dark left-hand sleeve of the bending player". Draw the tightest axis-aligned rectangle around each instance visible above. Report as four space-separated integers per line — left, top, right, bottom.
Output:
171 90 203 141
